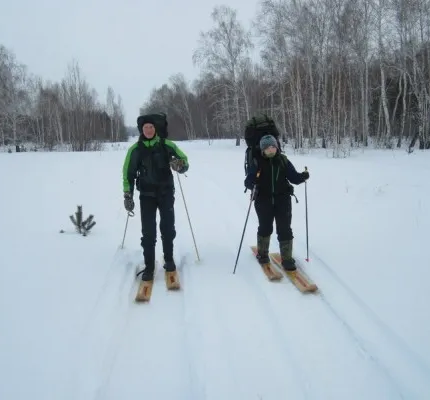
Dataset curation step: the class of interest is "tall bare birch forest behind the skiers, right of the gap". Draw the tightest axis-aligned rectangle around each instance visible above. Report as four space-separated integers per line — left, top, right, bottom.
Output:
140 0 430 154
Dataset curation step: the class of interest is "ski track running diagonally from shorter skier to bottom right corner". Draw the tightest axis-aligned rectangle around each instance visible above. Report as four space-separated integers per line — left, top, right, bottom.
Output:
298 241 430 399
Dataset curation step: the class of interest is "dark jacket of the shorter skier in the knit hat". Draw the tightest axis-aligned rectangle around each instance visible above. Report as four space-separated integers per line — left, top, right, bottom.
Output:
246 151 305 198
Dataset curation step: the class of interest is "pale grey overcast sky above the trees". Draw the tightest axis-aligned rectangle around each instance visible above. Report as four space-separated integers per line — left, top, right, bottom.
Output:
0 0 258 126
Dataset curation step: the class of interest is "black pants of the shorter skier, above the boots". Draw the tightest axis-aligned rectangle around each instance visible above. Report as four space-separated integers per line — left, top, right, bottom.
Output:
254 195 293 242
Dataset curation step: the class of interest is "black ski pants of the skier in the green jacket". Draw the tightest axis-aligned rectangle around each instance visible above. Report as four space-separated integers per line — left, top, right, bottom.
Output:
140 188 176 276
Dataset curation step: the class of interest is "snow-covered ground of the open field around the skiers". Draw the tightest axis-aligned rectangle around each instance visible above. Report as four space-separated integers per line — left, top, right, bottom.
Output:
0 141 430 400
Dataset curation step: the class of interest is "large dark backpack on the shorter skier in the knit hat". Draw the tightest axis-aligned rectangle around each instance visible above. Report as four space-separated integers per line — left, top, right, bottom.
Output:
245 114 282 175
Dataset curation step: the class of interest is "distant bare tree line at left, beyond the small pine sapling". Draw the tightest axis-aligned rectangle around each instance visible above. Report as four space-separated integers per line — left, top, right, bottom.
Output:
0 45 127 151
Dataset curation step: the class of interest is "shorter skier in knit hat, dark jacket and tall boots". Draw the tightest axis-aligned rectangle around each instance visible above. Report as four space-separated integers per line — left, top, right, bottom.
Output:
245 135 309 271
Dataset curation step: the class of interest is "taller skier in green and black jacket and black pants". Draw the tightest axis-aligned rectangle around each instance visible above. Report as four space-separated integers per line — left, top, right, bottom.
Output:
123 114 189 297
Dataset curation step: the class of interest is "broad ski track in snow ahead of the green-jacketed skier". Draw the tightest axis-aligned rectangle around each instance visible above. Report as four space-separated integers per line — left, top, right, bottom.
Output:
95 253 196 399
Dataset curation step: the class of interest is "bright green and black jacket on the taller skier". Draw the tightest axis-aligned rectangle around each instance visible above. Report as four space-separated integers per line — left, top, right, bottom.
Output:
122 134 189 196
